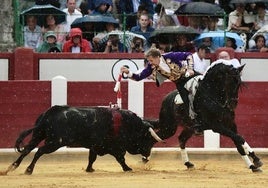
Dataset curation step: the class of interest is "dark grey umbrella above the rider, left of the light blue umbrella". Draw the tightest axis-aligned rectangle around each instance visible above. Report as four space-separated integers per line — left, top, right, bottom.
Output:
148 25 199 43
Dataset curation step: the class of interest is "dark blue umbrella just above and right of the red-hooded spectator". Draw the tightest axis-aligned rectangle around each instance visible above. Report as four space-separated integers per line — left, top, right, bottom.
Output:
71 14 119 31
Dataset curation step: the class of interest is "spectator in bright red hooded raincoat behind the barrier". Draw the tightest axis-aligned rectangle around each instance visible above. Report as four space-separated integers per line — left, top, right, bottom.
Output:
62 28 91 53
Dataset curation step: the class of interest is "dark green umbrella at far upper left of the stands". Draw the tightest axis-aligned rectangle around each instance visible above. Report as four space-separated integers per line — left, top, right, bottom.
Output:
20 4 66 26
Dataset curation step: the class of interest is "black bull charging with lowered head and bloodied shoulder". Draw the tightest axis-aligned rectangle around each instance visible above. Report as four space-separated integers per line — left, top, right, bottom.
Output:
2 106 160 174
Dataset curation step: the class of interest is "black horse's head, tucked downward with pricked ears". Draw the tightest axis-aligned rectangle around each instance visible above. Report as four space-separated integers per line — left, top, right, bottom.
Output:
205 63 245 111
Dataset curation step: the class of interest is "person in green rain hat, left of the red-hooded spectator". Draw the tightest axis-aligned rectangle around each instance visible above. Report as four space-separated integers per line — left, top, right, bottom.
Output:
36 31 62 53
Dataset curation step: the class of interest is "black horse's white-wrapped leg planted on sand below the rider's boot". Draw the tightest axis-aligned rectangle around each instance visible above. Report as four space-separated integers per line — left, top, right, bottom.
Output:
178 128 194 169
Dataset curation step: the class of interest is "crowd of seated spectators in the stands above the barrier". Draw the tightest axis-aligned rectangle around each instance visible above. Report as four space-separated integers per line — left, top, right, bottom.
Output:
23 0 268 53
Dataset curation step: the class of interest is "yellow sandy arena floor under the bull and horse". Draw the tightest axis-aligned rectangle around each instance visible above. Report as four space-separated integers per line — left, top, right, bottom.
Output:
0 152 268 188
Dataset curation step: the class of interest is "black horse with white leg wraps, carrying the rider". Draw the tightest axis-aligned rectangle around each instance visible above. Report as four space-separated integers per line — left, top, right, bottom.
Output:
151 63 262 172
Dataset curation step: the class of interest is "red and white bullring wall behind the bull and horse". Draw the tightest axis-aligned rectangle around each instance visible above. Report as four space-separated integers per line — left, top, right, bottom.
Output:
0 48 268 148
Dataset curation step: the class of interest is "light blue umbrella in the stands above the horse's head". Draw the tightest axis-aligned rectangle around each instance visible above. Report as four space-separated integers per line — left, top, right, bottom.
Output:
194 31 244 47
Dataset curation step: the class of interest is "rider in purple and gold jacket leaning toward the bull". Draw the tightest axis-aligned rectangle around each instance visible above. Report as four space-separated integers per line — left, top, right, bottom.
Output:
121 48 203 135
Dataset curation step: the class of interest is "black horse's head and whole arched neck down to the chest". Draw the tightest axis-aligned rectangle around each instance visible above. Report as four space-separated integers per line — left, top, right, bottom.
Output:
195 62 244 115
